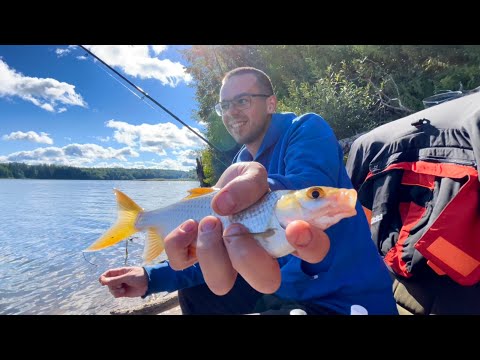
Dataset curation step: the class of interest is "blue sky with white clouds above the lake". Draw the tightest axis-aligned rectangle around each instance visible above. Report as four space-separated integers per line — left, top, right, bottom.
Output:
0 45 205 170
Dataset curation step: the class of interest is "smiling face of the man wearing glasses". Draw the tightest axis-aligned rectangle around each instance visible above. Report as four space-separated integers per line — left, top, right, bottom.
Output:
220 74 276 146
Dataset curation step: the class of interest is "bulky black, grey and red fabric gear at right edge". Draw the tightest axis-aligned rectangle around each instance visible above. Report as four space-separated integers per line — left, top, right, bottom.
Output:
347 93 480 285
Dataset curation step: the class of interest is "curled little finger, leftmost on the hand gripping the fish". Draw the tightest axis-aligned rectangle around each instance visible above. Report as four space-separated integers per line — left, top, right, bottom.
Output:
165 219 198 270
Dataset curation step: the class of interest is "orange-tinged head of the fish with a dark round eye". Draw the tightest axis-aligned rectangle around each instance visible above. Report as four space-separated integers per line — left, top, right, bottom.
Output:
275 186 357 230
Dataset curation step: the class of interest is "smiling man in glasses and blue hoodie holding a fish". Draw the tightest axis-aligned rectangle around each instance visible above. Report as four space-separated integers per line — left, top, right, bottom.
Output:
100 67 397 314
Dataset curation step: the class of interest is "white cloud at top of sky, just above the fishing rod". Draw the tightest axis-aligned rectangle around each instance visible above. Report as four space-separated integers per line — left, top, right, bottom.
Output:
85 45 192 87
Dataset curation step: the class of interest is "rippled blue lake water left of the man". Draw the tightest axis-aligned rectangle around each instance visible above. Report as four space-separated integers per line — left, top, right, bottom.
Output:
0 179 198 314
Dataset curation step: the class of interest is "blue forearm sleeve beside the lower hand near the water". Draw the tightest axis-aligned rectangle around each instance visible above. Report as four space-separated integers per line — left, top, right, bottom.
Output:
143 261 205 297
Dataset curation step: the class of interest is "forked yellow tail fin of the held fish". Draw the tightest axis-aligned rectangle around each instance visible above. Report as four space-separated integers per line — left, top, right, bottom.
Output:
84 189 143 251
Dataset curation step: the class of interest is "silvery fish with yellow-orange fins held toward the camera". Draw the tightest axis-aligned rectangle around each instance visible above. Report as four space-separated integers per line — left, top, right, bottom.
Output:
83 186 357 264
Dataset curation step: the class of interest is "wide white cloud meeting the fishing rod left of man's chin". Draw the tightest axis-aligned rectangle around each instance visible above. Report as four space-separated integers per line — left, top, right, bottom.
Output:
106 120 204 155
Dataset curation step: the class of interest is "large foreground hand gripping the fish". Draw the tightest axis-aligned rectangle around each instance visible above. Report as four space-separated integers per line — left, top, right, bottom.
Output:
165 162 330 295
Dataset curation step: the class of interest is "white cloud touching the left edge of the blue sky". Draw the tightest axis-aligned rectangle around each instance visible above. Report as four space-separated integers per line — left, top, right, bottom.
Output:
0 59 87 112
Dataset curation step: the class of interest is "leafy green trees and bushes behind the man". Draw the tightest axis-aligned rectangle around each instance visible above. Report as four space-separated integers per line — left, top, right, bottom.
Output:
183 45 480 184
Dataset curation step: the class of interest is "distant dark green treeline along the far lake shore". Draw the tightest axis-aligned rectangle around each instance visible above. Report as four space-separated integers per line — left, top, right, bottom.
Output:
0 163 196 180
